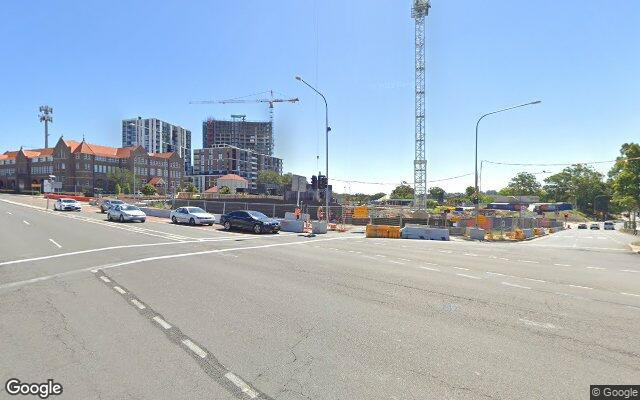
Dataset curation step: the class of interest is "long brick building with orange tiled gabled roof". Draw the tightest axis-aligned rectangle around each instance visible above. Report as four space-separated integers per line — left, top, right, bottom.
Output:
0 138 184 193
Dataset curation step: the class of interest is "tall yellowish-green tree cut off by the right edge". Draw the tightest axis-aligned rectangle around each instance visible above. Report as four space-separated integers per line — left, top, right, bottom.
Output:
609 143 640 211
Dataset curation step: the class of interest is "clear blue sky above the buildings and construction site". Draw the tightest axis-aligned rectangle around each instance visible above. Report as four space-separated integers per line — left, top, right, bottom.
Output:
0 0 640 193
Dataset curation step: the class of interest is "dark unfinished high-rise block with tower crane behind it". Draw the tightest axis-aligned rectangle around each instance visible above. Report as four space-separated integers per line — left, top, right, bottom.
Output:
202 116 273 156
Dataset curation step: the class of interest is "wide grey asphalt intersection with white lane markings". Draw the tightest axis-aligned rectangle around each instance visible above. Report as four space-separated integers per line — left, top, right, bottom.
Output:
0 195 640 399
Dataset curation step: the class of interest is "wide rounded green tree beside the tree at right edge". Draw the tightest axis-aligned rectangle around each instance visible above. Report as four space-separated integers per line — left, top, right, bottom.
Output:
544 164 607 214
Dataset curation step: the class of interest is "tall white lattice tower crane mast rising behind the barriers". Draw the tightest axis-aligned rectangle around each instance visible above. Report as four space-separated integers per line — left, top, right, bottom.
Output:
411 0 431 210
